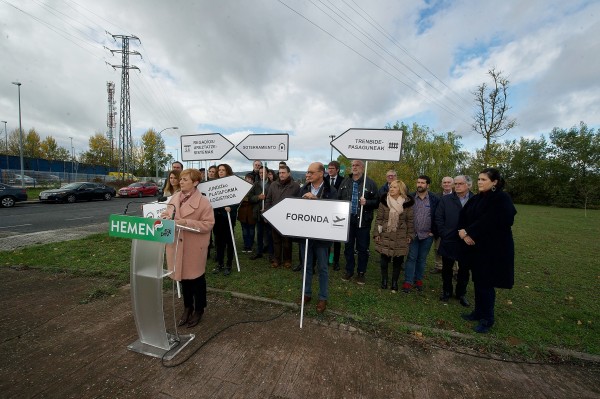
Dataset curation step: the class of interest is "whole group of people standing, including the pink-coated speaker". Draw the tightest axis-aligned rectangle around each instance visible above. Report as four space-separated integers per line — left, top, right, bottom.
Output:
159 160 516 333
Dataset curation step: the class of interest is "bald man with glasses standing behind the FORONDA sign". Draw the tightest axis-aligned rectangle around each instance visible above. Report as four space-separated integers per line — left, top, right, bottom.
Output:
298 162 337 313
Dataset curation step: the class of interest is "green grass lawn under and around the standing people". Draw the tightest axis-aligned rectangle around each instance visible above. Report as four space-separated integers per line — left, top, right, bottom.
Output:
0 205 600 357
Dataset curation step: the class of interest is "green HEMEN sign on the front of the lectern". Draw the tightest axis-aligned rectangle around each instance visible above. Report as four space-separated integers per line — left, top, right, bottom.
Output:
108 215 175 243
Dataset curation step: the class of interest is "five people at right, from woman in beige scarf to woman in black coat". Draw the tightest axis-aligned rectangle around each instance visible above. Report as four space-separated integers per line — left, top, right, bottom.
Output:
370 168 516 333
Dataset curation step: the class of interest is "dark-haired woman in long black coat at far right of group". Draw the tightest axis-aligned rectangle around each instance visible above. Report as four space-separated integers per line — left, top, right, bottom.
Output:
458 168 517 333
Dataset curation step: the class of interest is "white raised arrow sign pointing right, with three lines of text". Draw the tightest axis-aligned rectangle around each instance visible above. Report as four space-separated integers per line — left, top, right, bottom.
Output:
181 133 234 161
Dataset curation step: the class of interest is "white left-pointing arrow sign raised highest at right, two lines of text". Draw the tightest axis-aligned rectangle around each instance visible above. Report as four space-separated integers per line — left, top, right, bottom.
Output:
331 129 402 162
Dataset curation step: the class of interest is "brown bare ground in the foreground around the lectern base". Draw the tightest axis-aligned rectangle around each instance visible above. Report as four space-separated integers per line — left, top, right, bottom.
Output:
0 268 600 399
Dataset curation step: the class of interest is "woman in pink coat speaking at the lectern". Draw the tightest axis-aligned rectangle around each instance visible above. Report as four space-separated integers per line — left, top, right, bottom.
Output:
161 169 215 327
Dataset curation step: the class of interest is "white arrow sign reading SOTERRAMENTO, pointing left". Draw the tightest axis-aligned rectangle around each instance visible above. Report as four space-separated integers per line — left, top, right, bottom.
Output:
235 133 289 161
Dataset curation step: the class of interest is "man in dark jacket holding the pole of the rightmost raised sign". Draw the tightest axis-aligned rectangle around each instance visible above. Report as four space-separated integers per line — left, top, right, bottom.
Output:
338 159 379 285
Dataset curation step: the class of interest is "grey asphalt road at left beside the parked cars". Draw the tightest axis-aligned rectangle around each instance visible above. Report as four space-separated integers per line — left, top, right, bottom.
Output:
0 197 156 237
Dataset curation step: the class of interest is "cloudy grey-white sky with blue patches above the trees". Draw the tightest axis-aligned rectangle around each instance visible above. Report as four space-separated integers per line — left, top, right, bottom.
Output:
0 0 600 171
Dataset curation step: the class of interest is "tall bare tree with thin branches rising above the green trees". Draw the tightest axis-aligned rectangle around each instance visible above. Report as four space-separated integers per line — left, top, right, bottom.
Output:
471 68 517 167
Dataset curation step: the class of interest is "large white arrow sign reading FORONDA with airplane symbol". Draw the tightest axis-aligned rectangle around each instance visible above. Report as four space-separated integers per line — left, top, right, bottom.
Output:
263 198 350 242
